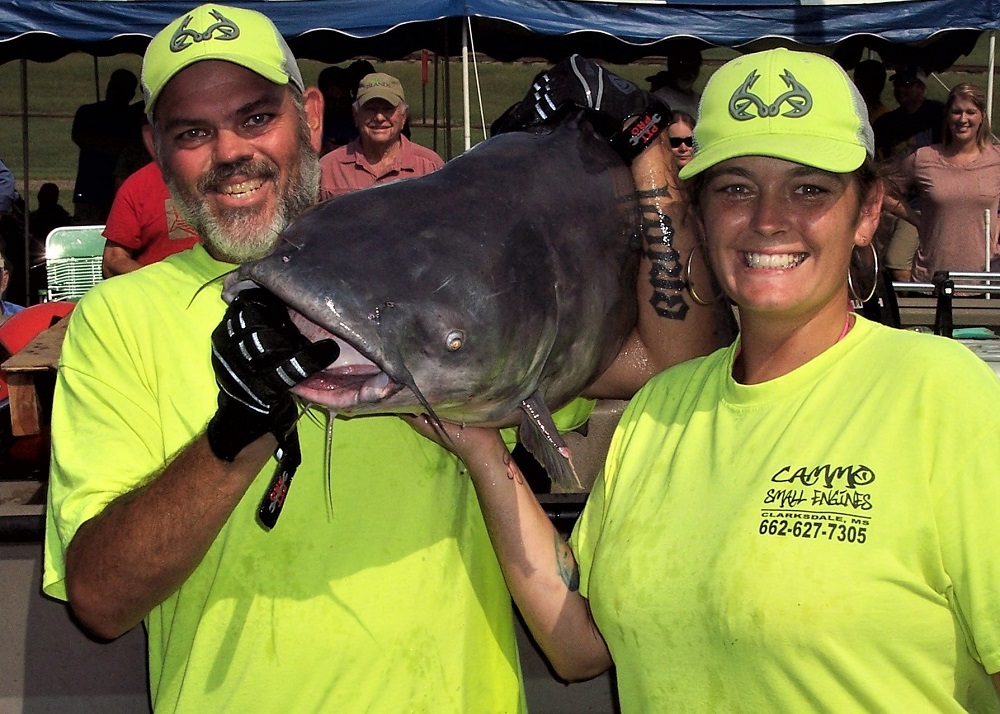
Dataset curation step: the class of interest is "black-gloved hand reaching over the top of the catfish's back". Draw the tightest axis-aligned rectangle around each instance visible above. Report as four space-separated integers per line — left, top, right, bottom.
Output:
490 55 671 162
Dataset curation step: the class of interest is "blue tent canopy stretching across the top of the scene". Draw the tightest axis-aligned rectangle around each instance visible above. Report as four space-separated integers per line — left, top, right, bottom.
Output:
0 0 1000 69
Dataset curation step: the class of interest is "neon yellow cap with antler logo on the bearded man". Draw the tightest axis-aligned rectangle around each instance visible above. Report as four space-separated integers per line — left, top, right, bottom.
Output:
142 4 305 117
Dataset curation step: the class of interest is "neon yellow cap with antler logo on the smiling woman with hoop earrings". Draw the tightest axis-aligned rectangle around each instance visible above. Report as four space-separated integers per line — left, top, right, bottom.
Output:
680 48 875 178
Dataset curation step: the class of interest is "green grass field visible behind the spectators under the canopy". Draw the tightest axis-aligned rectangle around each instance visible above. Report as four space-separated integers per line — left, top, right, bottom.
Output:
0 35 988 208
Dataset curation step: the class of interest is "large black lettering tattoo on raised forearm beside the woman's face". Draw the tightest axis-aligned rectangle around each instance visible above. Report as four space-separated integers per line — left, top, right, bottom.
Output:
639 195 690 320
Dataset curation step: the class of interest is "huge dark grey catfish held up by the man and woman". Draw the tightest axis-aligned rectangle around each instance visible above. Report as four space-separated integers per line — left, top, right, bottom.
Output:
228 114 639 484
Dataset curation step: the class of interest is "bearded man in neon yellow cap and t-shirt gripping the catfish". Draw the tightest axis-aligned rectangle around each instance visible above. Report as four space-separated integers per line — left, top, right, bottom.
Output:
43 5 728 712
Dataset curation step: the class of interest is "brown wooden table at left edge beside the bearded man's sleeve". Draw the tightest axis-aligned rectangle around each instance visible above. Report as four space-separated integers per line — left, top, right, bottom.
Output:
0 318 69 436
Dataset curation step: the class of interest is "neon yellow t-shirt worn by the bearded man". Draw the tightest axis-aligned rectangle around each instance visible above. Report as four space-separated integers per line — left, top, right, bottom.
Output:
44 246 525 714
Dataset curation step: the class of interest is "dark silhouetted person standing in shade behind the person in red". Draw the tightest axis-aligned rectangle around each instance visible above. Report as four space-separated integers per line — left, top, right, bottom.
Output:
72 69 139 224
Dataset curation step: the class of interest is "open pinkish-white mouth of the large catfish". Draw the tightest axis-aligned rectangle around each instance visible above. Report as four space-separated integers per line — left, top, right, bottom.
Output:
288 309 404 412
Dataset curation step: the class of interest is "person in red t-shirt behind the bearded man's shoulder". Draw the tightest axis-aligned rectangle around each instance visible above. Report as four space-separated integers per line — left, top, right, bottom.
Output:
101 161 199 278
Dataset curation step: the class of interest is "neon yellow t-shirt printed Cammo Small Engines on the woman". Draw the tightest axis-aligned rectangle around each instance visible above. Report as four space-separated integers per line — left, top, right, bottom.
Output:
572 318 1000 714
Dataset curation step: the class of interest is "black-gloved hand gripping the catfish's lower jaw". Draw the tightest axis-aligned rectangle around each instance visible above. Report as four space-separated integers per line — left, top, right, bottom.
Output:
208 288 340 461
